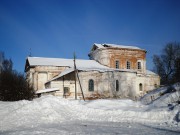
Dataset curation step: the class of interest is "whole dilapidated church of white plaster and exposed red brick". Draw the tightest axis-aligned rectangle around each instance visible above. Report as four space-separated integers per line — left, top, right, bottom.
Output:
25 44 160 99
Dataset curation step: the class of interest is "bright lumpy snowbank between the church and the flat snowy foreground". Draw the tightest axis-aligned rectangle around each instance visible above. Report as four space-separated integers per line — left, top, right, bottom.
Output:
0 96 180 131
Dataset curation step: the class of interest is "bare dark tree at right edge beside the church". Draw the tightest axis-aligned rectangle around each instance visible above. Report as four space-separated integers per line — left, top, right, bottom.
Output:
153 42 180 84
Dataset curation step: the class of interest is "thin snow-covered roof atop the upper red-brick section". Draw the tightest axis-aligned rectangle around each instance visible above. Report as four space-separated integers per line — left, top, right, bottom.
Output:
94 43 145 51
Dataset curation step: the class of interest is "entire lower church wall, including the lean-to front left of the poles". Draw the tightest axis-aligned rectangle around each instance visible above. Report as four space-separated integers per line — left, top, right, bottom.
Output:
47 71 159 99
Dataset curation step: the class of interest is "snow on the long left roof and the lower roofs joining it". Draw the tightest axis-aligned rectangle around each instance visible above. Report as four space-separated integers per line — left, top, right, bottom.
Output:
27 57 136 74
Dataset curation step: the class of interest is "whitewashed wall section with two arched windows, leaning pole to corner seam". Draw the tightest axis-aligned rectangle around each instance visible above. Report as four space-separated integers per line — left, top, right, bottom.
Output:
76 71 136 98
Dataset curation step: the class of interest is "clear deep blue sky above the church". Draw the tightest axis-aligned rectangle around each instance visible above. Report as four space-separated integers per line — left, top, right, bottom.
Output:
0 0 180 73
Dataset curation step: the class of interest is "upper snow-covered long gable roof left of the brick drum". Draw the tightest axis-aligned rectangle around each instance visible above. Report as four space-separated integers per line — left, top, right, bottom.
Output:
27 57 109 69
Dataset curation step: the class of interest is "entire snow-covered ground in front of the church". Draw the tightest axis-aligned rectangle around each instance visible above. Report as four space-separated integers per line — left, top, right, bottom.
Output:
0 90 180 135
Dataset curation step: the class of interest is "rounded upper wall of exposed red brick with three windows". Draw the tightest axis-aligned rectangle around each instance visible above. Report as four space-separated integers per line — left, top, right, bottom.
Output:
89 48 146 73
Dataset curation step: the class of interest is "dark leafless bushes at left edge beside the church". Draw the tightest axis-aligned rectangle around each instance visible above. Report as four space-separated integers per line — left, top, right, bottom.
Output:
0 53 34 101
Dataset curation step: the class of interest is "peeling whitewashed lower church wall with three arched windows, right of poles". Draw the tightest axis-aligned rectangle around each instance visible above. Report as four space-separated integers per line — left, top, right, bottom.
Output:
79 71 160 99
